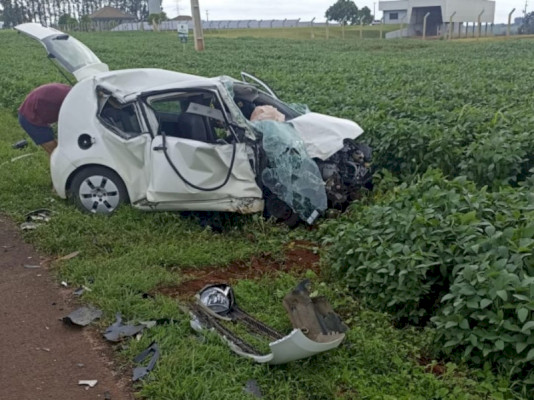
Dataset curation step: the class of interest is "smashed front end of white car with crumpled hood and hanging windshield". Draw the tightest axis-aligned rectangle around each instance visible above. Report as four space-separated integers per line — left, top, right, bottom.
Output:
219 74 372 226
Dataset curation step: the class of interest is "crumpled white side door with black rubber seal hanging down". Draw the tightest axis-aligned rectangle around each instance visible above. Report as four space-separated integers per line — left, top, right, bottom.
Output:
146 90 262 206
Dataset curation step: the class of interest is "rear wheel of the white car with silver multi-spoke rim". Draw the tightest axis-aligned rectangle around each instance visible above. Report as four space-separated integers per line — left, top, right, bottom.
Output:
70 167 128 214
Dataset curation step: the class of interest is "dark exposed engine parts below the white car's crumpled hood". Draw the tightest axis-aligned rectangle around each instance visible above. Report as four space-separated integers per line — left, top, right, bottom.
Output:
315 139 372 210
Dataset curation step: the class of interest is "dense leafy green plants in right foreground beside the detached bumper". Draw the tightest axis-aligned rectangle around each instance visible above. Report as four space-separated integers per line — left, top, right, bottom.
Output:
321 170 534 384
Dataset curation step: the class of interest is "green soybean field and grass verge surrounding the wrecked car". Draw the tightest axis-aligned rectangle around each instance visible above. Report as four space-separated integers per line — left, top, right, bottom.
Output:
0 31 534 400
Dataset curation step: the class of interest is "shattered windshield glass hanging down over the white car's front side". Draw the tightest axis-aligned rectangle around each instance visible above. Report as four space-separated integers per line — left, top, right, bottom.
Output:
219 76 327 223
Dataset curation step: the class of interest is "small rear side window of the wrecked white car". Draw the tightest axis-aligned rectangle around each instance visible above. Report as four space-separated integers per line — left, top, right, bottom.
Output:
100 97 143 139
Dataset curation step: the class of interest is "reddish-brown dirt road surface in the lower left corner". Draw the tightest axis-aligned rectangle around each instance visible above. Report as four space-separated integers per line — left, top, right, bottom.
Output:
0 215 133 400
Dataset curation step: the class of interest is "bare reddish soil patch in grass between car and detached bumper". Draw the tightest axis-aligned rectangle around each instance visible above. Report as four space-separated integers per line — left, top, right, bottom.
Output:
154 241 320 299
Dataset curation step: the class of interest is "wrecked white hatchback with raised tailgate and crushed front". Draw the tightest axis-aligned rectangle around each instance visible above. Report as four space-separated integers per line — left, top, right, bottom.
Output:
15 23 371 224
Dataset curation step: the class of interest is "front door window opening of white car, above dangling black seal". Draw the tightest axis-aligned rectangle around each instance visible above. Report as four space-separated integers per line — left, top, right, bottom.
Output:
148 92 229 143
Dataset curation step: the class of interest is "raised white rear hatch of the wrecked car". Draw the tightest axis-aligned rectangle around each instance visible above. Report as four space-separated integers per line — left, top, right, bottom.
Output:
15 23 109 81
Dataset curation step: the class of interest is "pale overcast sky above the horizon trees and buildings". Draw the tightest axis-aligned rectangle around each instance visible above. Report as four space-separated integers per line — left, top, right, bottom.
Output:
162 0 534 23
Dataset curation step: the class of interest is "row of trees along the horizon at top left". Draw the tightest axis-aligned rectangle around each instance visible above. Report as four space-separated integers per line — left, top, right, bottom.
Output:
0 0 148 28
